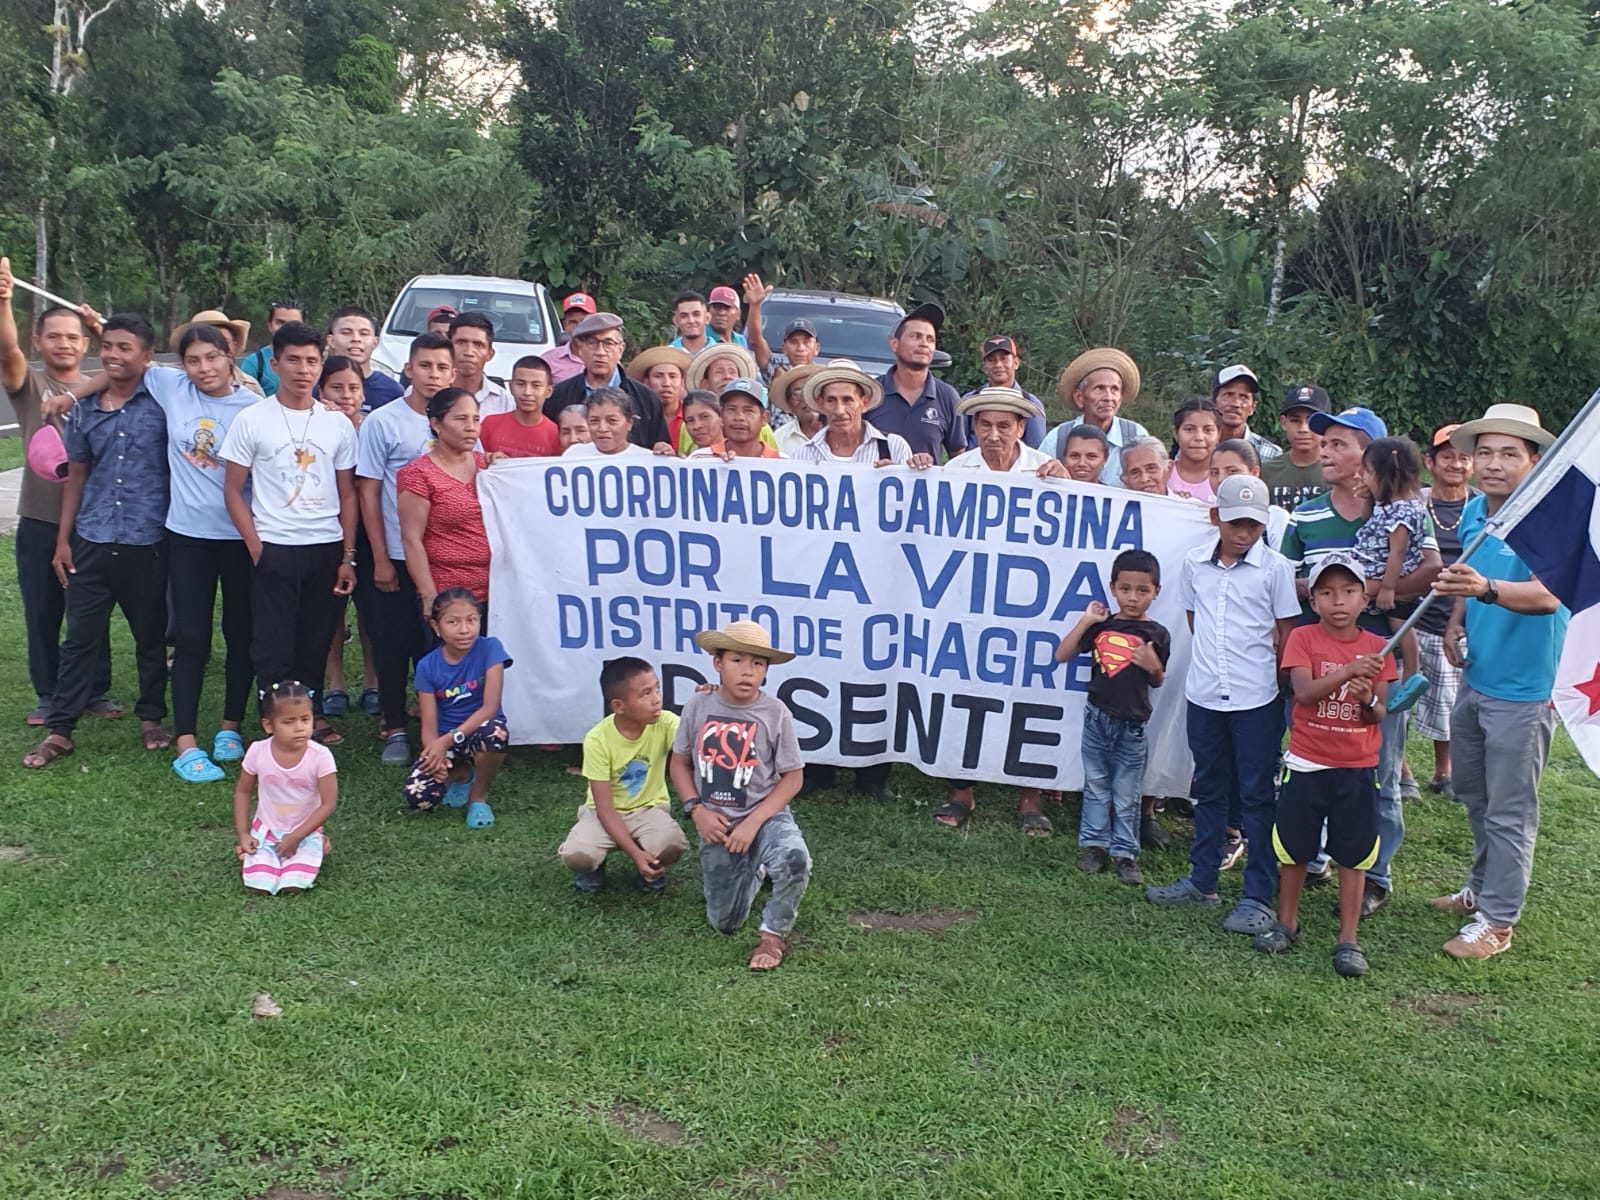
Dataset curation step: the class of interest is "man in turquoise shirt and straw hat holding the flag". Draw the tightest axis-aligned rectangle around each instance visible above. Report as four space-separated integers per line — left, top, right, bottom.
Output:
1434 405 1568 958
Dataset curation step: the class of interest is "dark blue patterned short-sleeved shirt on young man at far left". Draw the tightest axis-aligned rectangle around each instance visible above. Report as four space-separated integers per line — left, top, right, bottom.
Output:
62 382 171 546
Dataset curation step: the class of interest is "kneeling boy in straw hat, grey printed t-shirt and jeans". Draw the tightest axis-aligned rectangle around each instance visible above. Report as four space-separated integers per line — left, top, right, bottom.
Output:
672 621 811 971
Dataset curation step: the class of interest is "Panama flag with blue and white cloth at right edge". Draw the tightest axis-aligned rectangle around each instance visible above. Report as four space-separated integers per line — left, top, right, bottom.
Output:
1490 392 1600 774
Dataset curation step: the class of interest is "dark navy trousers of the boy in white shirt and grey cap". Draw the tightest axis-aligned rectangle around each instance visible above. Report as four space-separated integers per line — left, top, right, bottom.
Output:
1189 696 1283 906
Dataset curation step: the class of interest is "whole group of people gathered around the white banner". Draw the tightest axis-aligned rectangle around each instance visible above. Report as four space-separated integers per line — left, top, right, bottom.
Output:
0 259 1565 974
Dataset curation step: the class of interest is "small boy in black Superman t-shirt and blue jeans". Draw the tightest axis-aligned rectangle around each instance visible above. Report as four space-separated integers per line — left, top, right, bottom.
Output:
1056 550 1173 883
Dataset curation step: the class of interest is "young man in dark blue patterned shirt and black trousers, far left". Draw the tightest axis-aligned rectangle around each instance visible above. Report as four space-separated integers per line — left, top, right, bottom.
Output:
22 315 173 768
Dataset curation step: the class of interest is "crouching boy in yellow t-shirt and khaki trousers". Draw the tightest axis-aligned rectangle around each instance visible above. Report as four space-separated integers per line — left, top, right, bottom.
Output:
555 658 690 893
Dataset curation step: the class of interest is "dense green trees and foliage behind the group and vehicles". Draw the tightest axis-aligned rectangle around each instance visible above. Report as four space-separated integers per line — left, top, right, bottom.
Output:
0 0 1600 427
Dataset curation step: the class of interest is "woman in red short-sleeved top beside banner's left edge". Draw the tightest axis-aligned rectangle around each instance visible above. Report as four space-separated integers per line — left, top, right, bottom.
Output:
395 387 490 624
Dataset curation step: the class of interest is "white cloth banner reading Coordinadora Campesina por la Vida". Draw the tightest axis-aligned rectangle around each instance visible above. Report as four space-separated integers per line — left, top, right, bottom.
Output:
478 456 1210 795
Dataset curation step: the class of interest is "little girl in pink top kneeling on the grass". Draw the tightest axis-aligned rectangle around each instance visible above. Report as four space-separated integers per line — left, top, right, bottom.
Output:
234 680 339 896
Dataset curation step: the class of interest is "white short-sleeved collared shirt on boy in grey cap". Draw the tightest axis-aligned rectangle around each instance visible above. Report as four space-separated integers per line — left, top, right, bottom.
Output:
1181 539 1301 712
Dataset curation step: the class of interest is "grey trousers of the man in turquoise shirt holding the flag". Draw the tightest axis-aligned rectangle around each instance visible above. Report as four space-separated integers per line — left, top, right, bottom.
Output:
1450 683 1555 926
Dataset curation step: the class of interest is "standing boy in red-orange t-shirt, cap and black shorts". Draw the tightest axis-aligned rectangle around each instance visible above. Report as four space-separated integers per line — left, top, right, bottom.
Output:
1254 554 1397 978
